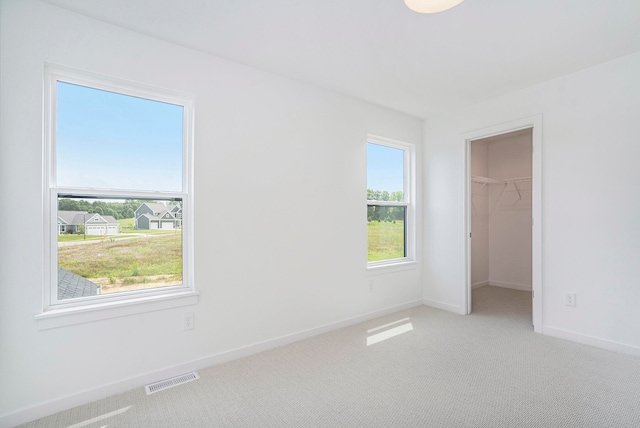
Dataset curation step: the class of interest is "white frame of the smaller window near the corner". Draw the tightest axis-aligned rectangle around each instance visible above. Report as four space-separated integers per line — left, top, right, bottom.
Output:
365 135 416 271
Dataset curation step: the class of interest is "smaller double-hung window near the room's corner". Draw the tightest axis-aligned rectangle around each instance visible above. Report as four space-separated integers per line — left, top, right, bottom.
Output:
367 137 414 267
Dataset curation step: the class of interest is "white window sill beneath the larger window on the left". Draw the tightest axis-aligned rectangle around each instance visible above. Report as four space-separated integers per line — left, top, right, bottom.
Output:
35 291 198 330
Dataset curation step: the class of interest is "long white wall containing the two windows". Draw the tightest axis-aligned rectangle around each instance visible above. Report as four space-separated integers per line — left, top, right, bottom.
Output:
0 0 423 425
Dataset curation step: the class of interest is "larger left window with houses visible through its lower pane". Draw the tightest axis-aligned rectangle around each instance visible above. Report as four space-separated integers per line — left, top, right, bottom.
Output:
44 67 193 311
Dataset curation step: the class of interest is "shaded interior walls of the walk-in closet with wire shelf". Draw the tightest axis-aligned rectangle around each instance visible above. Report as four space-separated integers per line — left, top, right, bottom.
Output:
471 129 532 291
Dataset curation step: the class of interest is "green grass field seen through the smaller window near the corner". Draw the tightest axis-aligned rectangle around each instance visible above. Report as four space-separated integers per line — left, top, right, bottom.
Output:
367 221 404 262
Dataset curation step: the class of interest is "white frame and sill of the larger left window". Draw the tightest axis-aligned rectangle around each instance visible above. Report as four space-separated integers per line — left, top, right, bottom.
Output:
36 63 198 329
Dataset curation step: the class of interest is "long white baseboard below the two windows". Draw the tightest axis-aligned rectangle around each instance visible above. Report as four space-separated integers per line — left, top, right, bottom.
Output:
0 300 423 427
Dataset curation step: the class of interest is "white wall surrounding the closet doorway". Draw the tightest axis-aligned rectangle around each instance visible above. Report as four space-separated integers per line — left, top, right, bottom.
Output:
423 49 640 355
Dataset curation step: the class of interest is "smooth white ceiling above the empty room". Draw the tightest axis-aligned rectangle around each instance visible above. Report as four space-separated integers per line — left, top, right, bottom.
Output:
43 0 640 118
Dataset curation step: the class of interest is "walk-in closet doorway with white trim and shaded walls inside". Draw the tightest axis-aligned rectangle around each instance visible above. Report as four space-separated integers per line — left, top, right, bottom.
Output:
465 117 542 332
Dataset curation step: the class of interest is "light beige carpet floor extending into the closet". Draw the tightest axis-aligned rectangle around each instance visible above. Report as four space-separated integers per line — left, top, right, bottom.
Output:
18 287 640 428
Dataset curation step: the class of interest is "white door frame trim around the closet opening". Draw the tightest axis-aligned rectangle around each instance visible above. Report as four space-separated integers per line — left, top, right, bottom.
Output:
462 115 543 333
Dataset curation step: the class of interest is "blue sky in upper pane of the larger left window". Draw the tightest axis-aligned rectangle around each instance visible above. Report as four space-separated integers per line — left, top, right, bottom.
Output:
56 82 183 192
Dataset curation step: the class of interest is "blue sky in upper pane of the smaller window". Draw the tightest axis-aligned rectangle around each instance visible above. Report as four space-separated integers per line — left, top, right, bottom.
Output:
367 143 404 193
